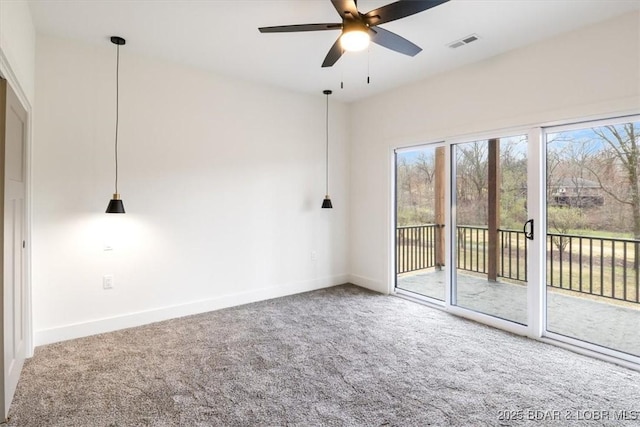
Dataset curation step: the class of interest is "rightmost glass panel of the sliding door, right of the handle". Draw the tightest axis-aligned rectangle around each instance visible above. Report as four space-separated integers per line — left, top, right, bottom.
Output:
545 117 640 356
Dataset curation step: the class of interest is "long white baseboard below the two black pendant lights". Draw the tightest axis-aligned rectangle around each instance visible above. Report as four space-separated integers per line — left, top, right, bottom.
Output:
34 274 349 346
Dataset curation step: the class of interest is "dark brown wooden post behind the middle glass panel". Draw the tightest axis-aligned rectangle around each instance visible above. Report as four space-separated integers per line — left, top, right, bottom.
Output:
487 139 500 282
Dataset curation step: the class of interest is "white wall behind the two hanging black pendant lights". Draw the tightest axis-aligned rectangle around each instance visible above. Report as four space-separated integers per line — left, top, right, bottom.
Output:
33 37 349 345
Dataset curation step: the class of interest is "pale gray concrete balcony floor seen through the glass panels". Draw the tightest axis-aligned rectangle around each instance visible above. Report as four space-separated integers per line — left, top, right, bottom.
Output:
397 269 640 357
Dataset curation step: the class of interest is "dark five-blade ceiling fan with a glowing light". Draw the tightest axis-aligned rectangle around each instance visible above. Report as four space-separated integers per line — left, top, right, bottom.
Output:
258 0 449 67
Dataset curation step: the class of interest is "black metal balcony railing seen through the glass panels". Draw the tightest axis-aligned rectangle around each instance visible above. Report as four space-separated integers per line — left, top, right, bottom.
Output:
396 224 640 303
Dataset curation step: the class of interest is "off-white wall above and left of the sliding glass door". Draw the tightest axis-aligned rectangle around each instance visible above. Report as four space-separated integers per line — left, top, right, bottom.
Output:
350 13 640 292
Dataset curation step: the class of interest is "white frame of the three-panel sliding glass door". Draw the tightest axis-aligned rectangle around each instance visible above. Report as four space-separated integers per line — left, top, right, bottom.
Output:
389 116 640 370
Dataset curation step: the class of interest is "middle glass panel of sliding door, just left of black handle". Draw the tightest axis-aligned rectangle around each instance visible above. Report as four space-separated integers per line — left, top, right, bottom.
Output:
452 135 533 325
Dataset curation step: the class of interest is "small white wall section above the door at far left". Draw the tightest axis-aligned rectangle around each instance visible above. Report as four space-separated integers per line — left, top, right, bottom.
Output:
0 0 36 104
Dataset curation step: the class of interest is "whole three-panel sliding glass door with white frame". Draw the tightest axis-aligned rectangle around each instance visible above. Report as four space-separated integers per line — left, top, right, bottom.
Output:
394 116 640 363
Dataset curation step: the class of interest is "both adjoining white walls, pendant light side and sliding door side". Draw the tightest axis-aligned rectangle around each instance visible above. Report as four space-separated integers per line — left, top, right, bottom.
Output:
27 9 640 344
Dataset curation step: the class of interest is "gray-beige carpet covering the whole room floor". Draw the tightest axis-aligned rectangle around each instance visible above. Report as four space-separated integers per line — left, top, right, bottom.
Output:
9 285 640 427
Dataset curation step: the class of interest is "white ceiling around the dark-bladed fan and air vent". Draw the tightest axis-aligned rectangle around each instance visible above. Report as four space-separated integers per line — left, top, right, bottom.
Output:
29 0 640 102
